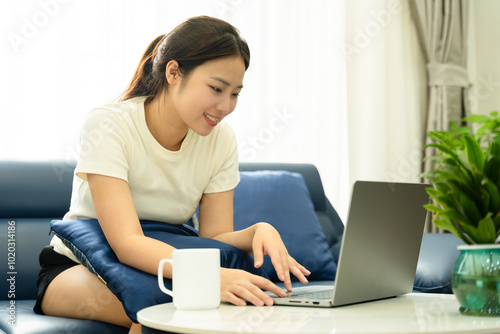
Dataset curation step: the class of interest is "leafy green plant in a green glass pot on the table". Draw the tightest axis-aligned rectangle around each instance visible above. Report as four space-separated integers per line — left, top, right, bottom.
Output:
424 111 500 316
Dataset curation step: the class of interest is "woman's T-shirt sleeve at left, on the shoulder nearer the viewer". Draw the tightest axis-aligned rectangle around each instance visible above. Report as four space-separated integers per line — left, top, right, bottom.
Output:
75 109 129 181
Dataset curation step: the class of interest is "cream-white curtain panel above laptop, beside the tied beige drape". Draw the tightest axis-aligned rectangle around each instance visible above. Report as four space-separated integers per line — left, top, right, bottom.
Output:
345 0 426 190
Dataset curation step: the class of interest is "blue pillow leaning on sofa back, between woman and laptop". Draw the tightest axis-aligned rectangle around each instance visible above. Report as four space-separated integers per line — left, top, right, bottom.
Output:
234 171 337 282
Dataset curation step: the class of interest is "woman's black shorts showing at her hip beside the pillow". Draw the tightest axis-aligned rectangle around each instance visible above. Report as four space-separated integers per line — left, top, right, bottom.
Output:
33 246 79 314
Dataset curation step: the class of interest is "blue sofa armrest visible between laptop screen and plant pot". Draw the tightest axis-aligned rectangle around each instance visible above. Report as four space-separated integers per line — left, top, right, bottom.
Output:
414 233 464 293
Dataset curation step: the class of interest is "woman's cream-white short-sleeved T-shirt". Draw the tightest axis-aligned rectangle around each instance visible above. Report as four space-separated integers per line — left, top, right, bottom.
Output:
51 97 240 260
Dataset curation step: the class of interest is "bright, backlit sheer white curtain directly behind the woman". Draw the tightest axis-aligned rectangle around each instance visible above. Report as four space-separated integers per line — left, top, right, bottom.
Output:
0 0 349 217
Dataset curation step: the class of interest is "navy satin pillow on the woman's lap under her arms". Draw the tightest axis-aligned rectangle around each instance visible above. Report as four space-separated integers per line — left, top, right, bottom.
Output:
50 220 266 322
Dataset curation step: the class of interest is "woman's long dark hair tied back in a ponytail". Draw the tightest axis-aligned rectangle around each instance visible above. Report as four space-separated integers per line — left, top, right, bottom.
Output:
119 16 250 103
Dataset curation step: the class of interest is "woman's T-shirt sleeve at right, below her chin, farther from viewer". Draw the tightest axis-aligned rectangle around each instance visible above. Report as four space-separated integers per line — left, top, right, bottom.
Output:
204 123 240 193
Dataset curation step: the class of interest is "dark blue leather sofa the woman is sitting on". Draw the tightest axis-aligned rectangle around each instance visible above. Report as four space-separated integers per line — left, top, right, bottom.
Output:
0 161 461 334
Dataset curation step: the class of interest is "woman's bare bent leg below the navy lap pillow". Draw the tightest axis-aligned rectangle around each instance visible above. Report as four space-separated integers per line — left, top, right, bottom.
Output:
42 265 133 333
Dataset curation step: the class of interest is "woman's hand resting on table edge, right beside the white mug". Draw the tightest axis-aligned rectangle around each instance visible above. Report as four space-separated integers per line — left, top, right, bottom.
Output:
220 268 286 306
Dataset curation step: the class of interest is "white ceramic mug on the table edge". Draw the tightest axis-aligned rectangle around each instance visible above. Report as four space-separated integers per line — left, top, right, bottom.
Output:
158 248 220 310
